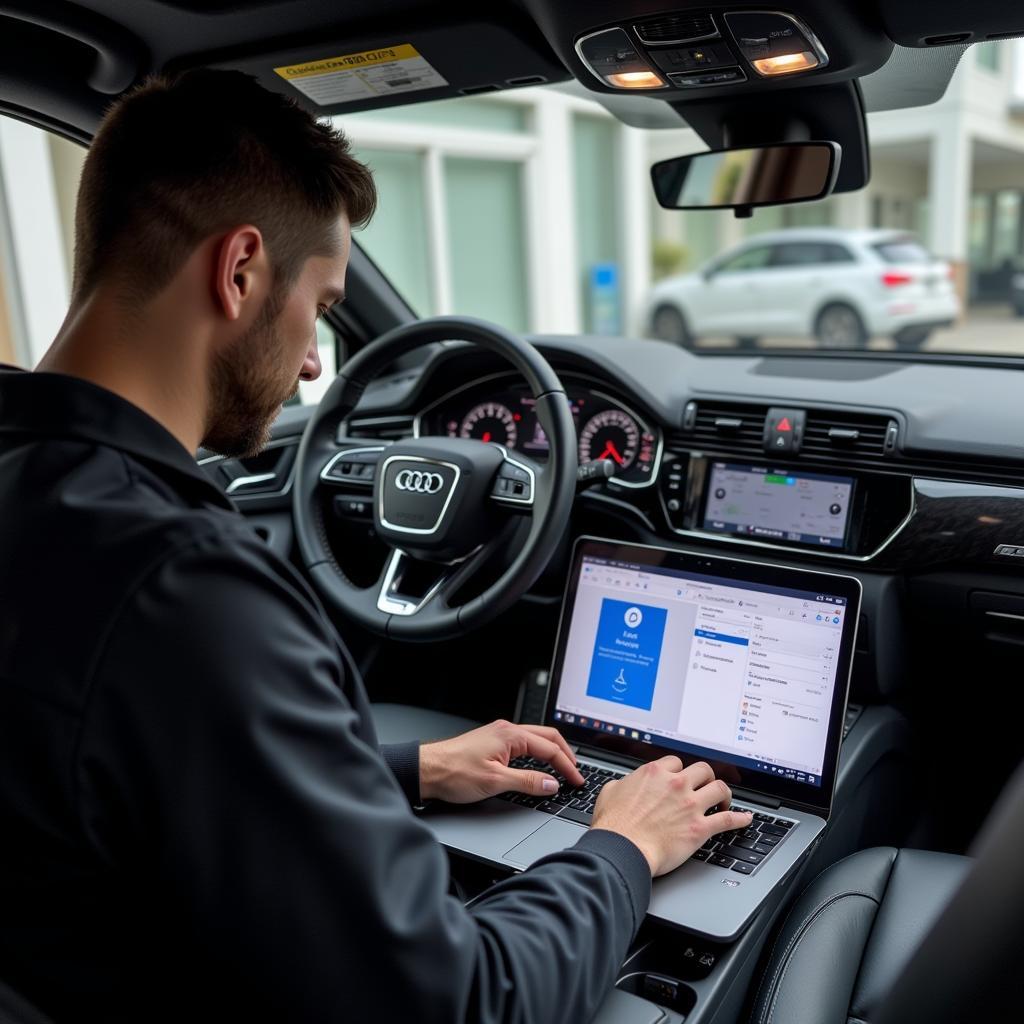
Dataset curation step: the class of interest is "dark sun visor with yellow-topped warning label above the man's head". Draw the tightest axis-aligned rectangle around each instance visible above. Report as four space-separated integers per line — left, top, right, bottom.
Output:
179 22 569 115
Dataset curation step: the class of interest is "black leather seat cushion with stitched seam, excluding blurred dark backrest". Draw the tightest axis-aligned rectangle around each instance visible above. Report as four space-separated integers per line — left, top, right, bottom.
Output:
751 847 972 1024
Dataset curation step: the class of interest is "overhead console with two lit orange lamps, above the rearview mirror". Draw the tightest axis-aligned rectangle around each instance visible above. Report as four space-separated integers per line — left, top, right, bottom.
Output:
524 0 893 191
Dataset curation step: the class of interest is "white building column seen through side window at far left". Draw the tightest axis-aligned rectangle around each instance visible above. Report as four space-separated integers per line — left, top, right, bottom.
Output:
0 118 69 367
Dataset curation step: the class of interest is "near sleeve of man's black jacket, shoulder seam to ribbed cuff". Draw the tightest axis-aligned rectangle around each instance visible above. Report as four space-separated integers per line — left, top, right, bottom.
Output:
75 539 650 1024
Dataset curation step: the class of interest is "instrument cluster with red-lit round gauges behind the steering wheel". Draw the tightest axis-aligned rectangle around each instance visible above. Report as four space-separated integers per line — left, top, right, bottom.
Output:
416 377 662 487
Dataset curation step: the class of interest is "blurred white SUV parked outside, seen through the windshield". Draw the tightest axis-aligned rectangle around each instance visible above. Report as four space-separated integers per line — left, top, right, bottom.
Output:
647 227 961 349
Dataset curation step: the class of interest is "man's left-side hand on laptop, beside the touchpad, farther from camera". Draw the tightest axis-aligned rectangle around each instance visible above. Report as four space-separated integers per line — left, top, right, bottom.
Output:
420 720 583 804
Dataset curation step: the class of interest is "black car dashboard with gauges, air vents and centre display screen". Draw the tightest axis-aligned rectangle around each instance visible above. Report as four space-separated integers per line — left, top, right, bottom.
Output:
333 337 1024 571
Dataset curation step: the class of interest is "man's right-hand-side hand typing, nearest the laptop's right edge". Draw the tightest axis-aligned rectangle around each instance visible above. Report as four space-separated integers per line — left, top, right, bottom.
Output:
593 755 751 876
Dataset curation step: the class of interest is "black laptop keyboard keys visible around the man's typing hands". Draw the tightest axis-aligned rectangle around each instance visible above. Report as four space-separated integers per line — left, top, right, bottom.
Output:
498 757 797 874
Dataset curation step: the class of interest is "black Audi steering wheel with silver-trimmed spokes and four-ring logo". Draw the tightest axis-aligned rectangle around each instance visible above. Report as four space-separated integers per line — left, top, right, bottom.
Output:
292 316 577 641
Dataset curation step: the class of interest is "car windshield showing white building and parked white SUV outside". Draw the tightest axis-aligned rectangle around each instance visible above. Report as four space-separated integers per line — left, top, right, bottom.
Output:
348 41 1024 354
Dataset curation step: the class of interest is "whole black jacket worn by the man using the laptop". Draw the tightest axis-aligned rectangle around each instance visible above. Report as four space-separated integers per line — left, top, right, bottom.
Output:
0 369 650 1024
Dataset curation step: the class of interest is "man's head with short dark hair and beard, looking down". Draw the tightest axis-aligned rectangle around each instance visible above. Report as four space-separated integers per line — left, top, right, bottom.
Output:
72 71 376 455
